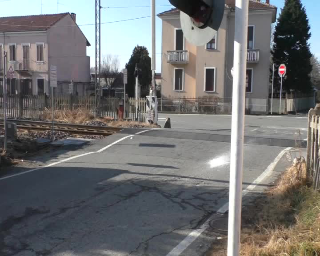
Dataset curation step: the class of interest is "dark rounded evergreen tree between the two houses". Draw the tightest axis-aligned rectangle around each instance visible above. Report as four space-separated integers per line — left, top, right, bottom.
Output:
126 45 152 97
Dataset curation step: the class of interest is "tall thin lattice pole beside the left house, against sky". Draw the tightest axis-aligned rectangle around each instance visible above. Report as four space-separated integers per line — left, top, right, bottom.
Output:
94 0 101 115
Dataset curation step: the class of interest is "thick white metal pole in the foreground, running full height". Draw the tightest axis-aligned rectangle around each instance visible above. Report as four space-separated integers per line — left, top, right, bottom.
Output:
228 0 249 256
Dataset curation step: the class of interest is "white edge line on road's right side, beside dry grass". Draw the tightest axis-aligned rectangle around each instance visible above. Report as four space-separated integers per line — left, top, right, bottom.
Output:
167 148 292 256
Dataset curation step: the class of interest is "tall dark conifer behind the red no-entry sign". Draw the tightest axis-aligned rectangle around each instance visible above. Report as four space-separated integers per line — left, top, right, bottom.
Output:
272 0 312 92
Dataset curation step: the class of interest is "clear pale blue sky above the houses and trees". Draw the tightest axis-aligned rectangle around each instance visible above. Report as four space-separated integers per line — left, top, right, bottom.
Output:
0 0 320 72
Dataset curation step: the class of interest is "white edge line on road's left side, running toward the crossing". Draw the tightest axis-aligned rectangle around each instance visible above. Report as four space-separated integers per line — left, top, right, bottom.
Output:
0 130 154 181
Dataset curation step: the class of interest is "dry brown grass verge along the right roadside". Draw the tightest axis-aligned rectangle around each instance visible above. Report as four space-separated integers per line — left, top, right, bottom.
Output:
206 159 320 256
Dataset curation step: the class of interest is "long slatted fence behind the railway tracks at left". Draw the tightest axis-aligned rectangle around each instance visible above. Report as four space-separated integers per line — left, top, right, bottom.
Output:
0 95 146 121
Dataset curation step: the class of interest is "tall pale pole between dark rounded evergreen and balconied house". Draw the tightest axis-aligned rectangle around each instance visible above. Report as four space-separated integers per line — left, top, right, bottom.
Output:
150 0 157 96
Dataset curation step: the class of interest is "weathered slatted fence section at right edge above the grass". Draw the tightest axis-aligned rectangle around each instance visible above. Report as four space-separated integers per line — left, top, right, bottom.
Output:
307 104 320 190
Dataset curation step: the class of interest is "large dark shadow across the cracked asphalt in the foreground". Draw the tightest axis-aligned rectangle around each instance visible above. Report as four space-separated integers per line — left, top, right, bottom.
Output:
0 163 280 256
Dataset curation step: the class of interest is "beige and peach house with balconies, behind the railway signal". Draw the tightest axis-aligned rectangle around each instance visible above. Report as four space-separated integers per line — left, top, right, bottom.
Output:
158 0 277 113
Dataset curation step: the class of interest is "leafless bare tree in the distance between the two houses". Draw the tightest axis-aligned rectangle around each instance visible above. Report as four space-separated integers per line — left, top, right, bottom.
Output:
101 54 120 89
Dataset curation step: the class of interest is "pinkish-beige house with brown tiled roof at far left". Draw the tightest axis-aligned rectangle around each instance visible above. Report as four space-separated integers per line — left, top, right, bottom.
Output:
0 13 90 95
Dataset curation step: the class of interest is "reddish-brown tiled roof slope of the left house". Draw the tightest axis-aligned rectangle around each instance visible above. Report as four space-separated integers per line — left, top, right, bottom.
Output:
0 13 69 32
